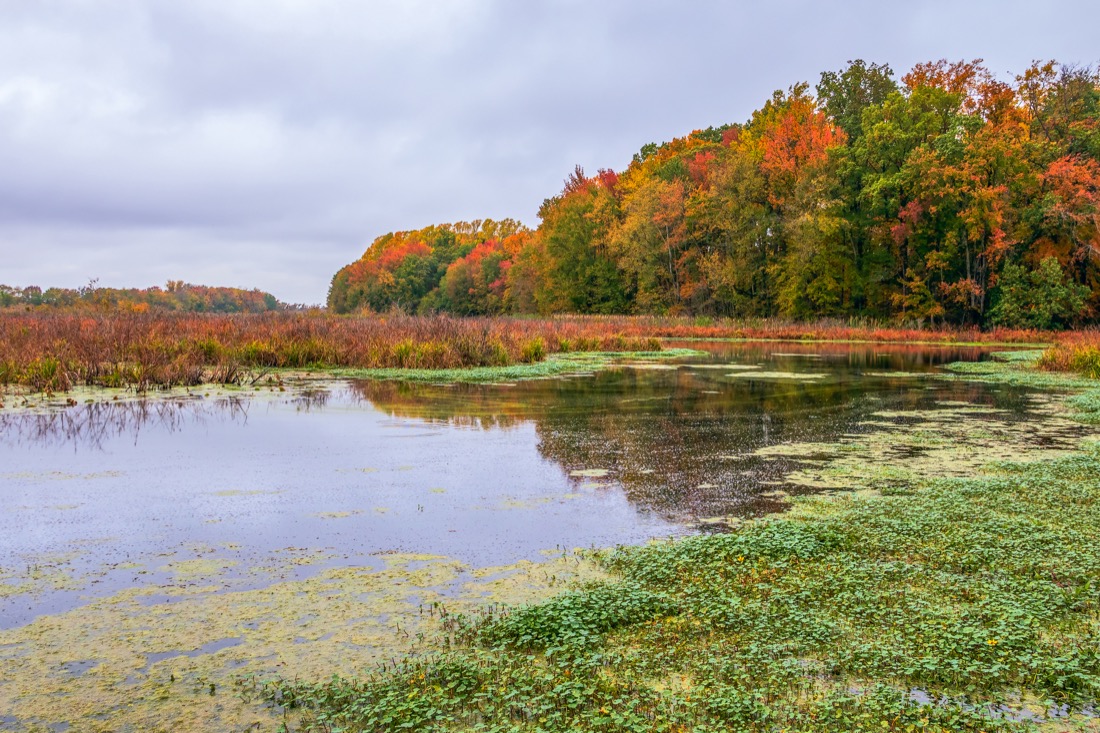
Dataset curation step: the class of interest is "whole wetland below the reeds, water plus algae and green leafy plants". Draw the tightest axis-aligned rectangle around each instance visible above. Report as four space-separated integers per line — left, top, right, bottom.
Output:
0 342 1100 731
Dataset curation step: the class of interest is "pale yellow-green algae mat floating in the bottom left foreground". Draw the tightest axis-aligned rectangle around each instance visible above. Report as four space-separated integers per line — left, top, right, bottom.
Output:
0 551 606 733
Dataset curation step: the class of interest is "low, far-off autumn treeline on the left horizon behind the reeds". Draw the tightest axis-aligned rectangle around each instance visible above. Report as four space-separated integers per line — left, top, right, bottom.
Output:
0 280 289 313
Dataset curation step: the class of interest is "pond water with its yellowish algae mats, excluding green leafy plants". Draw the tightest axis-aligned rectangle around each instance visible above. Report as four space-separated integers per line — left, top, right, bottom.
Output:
0 342 1080 730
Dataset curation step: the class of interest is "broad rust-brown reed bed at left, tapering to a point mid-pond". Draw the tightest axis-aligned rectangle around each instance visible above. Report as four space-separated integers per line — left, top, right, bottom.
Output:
0 313 660 392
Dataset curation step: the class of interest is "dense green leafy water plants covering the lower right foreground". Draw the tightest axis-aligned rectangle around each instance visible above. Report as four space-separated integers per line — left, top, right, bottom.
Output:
261 359 1100 733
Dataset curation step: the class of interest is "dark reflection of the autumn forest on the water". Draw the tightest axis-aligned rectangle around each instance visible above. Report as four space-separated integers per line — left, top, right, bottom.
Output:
352 343 1026 522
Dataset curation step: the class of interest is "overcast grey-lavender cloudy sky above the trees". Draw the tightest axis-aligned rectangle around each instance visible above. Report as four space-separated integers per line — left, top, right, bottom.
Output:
0 0 1100 304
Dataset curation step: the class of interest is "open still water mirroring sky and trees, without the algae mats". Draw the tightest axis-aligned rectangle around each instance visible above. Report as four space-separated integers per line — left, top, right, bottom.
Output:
0 343 1051 628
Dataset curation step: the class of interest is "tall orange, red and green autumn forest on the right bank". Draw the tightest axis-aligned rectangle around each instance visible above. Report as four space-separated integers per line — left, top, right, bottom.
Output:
328 61 1100 328
